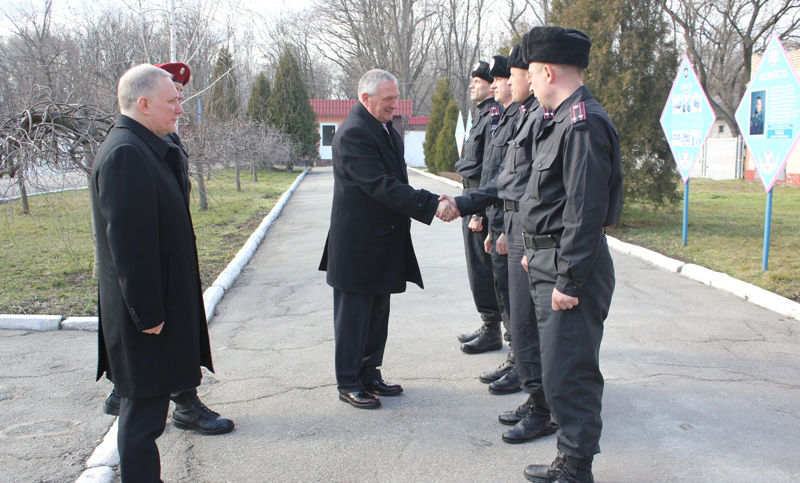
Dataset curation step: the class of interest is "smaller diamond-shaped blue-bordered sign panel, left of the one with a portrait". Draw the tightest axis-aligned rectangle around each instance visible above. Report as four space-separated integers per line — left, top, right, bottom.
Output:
661 54 716 184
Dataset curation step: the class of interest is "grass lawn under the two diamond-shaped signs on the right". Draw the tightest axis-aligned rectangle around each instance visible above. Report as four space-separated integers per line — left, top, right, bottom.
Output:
609 179 800 301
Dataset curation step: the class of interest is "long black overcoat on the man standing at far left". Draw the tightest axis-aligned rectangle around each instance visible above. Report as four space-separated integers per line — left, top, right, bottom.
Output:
90 115 213 398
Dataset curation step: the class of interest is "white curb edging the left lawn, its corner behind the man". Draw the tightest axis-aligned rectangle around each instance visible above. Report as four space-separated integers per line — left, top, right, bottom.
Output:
0 168 309 331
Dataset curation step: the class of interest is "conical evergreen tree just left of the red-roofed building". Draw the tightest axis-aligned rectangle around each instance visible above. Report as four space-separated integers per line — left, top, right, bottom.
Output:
267 50 319 161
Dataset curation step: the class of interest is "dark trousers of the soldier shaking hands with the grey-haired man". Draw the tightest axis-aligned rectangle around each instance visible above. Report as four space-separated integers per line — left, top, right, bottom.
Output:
506 213 542 395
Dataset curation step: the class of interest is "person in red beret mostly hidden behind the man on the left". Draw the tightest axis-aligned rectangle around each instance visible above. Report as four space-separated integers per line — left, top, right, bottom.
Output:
103 62 234 435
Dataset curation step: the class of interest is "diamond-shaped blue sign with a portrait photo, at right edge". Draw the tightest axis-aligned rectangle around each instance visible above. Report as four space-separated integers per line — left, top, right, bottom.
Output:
736 37 800 192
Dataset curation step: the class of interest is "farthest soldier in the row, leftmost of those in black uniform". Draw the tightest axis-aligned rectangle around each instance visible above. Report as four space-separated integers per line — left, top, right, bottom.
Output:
456 61 503 354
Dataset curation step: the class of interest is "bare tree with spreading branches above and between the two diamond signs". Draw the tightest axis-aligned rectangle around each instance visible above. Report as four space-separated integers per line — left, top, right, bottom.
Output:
661 0 800 134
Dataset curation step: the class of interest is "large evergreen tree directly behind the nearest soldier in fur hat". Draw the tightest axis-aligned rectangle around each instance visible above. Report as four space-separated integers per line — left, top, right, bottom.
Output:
551 0 679 206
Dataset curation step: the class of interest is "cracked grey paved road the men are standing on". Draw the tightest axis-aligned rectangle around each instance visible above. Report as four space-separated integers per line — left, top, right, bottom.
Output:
0 168 800 482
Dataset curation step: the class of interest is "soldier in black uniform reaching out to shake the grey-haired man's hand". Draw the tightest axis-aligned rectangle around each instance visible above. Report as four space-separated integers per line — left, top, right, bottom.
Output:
438 44 557 443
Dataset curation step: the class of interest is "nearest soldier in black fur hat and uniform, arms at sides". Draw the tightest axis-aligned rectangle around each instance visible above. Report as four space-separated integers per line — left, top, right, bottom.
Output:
520 26 622 482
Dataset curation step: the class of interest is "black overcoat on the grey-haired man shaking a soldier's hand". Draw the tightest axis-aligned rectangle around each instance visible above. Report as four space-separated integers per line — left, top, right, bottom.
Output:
319 102 438 294
